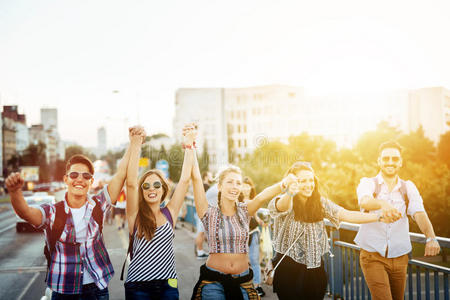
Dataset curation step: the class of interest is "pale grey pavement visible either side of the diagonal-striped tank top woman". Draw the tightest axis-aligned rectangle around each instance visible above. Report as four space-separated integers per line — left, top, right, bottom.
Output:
104 222 277 300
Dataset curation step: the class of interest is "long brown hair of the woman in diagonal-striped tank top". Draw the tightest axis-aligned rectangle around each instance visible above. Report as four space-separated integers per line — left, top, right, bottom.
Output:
136 169 169 241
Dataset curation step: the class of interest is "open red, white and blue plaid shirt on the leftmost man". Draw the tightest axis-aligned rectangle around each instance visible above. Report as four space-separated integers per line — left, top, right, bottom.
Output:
38 185 114 294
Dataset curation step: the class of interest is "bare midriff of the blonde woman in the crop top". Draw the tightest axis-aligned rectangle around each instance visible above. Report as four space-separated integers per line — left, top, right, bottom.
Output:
206 253 249 275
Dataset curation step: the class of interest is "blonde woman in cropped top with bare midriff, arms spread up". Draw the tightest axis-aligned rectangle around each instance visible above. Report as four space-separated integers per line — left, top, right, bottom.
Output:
192 132 293 300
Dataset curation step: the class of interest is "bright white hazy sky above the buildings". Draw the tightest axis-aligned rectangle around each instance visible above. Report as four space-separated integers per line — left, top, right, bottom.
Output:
0 0 450 147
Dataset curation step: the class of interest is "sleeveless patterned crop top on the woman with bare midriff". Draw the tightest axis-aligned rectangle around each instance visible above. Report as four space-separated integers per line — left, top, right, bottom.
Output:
202 202 250 253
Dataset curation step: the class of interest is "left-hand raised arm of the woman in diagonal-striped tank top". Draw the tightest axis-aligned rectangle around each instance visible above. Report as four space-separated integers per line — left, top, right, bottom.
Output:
126 130 145 233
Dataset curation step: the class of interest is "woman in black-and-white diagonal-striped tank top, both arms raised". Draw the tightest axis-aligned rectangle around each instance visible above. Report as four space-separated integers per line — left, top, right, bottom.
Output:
125 126 194 300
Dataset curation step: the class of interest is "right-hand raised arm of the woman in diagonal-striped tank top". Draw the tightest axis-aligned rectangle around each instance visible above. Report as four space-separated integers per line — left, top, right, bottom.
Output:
167 124 196 224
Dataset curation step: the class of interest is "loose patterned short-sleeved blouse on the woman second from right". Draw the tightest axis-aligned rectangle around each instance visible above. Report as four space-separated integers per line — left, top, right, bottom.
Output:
268 196 343 269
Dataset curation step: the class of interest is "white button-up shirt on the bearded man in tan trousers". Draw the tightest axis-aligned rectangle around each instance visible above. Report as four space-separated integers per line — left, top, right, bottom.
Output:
354 173 425 258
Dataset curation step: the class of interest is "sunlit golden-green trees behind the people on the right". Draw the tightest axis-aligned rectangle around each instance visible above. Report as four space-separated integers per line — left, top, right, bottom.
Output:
239 122 450 237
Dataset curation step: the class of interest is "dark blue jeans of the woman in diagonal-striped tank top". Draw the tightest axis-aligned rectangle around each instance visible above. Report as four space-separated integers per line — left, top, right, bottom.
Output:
125 279 180 300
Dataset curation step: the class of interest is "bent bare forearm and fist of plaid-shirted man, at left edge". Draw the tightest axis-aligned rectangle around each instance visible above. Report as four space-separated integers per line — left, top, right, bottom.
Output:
5 173 43 226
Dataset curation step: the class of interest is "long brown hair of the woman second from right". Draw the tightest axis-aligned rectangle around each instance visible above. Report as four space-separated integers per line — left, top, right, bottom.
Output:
284 161 325 223
